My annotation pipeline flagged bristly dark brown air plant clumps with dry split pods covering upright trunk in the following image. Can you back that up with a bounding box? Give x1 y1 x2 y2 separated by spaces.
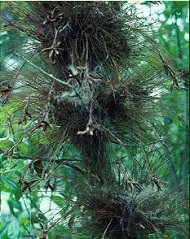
2 1 189 239
